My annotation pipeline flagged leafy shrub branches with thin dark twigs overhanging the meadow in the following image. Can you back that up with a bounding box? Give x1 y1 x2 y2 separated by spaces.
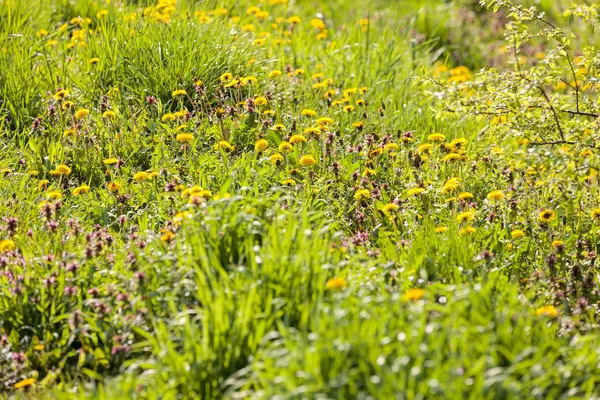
432 1 600 149
